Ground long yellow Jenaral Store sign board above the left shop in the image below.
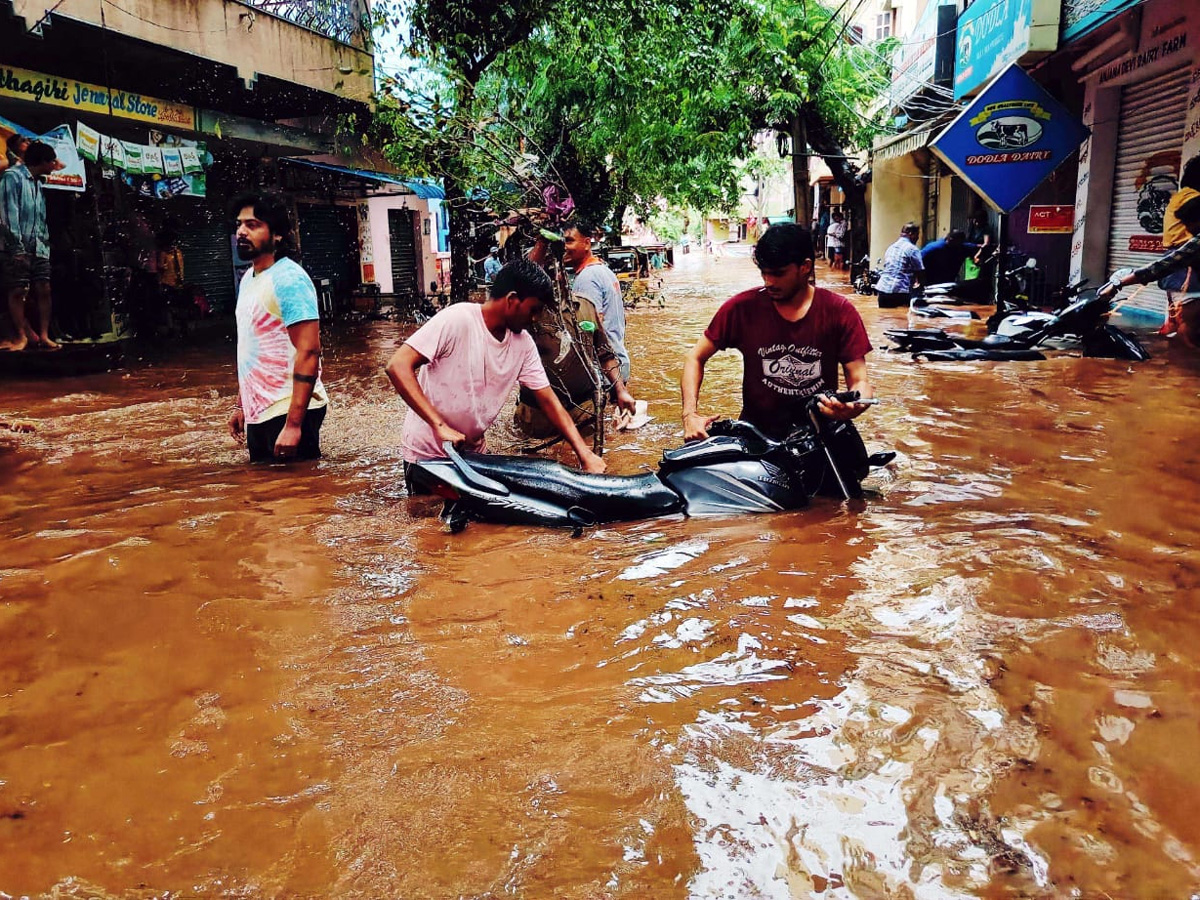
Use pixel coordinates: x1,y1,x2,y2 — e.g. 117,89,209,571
0,66,196,131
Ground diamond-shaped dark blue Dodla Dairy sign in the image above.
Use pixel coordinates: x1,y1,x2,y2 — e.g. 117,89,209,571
930,64,1087,212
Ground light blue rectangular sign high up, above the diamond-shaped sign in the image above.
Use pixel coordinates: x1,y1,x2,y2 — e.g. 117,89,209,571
954,0,1033,100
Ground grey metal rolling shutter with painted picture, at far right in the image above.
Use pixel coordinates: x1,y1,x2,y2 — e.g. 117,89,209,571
1108,68,1189,316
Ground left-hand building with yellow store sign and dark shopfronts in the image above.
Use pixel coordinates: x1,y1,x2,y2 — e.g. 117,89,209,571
0,0,441,337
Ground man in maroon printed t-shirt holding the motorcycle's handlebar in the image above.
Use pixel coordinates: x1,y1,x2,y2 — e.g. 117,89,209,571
680,224,874,440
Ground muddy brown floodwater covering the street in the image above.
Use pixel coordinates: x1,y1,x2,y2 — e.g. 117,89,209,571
0,248,1200,899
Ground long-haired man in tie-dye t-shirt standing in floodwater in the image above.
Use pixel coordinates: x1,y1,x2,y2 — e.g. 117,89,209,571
229,193,329,462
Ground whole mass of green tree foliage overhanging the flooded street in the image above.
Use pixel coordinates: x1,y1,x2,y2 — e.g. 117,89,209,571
377,0,889,260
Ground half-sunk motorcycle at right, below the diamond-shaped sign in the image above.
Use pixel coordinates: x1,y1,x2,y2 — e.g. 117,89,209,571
884,282,1150,361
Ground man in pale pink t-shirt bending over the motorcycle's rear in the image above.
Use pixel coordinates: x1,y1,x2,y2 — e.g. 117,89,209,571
388,259,605,489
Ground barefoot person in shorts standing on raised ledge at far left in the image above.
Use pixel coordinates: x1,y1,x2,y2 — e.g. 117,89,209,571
0,140,59,350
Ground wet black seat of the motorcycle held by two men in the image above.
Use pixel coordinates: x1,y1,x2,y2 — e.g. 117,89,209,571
461,454,683,522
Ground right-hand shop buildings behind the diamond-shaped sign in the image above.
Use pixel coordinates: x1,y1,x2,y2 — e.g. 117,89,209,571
871,0,1200,319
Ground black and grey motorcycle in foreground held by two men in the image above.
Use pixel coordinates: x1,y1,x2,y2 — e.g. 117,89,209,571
409,391,895,535
